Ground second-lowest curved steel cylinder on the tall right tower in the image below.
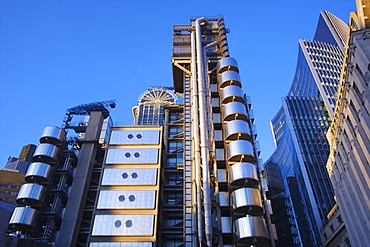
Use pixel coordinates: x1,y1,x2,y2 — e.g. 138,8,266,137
231,188,263,215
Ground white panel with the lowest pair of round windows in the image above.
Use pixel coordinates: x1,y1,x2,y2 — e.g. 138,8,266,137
92,215,154,236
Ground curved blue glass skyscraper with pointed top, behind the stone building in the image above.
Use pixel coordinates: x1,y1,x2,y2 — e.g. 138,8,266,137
265,11,348,246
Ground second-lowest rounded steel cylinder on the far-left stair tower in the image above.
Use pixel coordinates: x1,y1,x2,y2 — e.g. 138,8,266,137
16,184,46,206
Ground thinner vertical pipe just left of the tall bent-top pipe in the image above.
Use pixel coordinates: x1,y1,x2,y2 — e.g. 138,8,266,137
190,31,204,246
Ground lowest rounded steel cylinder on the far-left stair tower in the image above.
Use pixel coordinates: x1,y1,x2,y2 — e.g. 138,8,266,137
9,207,39,232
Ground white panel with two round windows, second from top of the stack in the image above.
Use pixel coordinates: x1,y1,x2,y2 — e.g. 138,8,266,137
105,148,158,164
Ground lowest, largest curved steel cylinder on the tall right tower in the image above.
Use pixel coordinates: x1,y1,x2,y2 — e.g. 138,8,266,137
235,216,269,244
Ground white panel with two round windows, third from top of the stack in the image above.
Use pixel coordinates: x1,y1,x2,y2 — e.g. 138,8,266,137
102,168,157,185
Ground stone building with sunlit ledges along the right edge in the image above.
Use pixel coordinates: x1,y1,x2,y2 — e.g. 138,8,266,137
324,0,370,246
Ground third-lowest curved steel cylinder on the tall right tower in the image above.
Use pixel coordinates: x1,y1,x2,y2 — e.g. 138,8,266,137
229,163,259,188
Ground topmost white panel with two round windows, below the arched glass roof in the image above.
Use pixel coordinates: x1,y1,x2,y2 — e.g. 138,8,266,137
109,130,159,144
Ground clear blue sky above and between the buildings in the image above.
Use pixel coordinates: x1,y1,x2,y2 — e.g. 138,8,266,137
0,0,355,167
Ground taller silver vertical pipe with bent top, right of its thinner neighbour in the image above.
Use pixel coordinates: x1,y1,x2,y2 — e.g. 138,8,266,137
195,17,212,246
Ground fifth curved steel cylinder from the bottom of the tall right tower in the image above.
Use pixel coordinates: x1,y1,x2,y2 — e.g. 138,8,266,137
225,120,252,141
